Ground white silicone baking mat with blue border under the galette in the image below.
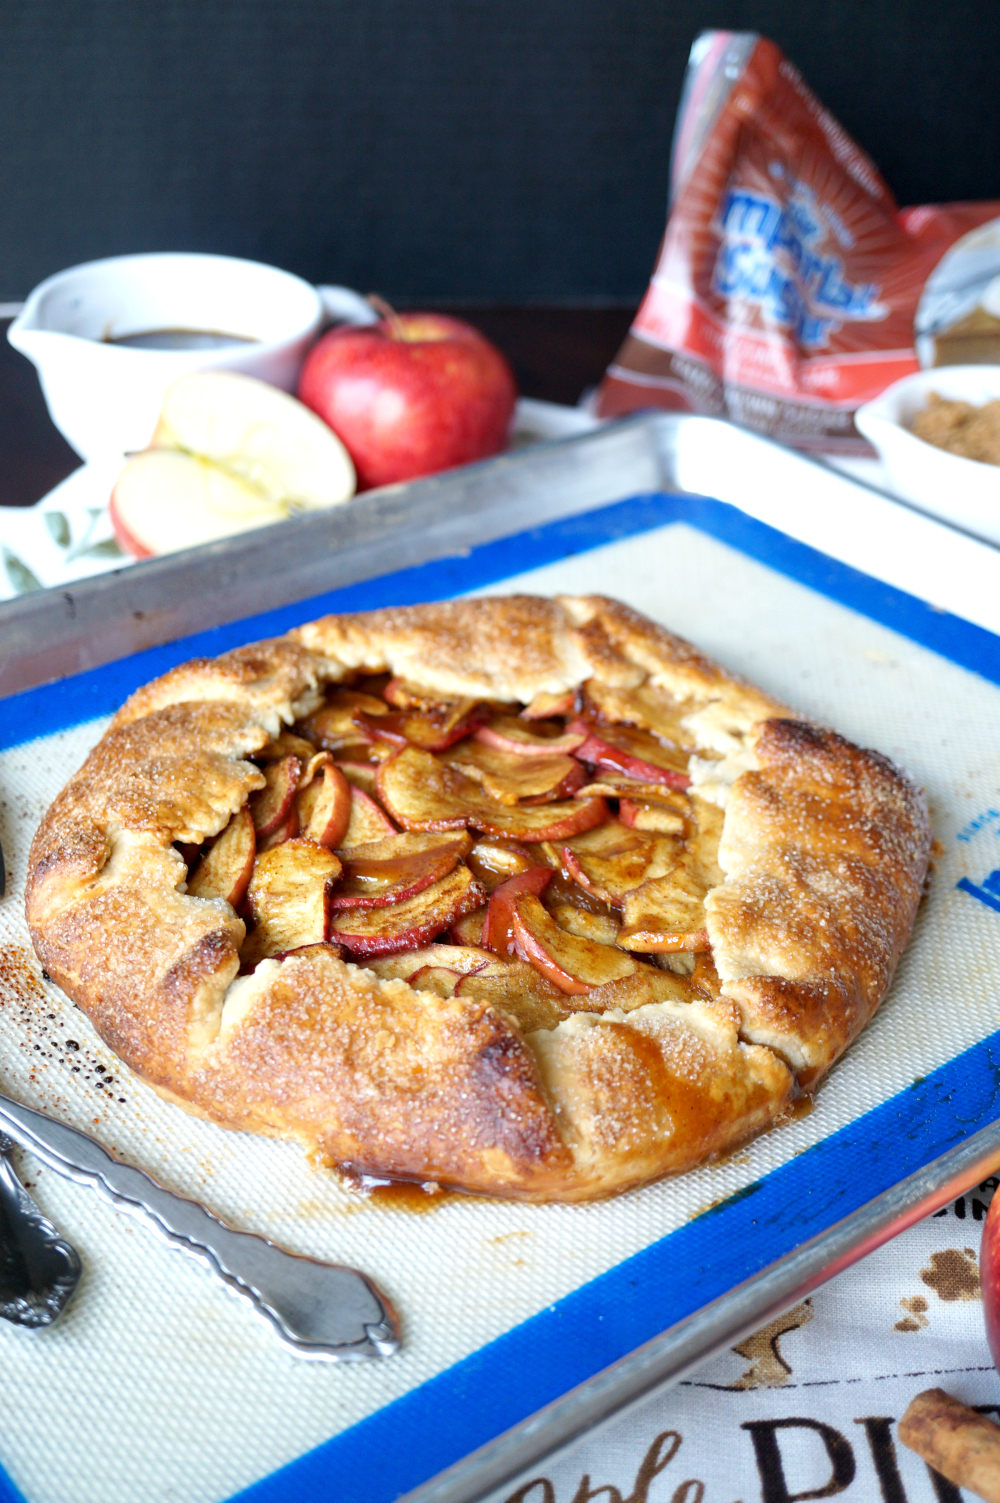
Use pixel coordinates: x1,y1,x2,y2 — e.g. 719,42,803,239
0,496,1000,1503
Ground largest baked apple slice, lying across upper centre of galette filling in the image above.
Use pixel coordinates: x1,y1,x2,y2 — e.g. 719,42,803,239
379,747,608,840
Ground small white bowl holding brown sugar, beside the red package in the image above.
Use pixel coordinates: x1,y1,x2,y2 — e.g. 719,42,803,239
854,365,1000,543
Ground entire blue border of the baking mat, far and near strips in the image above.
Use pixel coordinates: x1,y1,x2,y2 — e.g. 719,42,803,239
0,493,1000,1503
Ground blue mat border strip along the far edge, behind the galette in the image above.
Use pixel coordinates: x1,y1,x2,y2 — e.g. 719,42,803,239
0,491,1000,750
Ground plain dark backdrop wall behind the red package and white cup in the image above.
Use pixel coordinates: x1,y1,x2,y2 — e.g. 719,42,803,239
0,0,1000,307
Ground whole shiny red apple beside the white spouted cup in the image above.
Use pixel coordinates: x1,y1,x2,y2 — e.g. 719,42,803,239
298,313,517,490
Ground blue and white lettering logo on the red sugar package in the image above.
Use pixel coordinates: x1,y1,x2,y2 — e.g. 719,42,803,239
711,177,887,350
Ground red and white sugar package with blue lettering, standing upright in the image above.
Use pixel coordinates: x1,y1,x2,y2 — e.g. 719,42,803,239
597,32,1000,454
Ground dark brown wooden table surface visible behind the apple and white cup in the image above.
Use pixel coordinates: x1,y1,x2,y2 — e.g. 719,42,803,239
0,308,633,507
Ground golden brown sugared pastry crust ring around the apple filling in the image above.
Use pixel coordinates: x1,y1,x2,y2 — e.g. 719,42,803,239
27,597,929,1199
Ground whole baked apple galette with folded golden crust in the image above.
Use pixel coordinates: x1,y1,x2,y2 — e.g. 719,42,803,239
27,597,929,1199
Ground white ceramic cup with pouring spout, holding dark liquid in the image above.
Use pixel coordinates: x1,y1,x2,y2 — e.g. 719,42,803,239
8,253,323,460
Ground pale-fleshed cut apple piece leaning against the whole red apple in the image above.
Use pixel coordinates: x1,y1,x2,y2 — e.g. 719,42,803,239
152,370,356,516
